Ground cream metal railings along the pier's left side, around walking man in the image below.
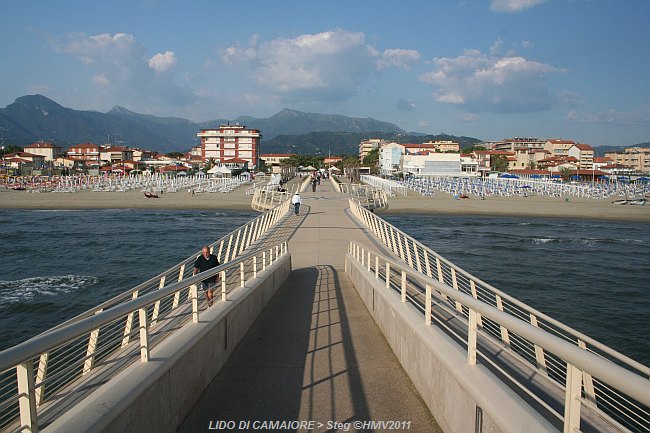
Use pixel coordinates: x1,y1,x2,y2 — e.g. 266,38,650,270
0,201,289,432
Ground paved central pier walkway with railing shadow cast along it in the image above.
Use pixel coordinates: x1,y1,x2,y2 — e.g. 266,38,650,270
178,181,441,433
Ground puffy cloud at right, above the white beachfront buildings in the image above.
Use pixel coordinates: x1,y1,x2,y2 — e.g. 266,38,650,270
420,45,563,113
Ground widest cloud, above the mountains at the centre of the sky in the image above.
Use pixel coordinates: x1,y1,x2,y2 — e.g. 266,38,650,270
221,30,419,101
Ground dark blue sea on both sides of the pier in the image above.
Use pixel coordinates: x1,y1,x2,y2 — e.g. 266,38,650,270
0,209,650,365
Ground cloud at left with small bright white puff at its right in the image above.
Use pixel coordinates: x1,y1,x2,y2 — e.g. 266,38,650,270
52,33,197,108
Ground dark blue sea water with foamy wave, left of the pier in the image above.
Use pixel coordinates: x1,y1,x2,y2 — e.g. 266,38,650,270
0,209,259,350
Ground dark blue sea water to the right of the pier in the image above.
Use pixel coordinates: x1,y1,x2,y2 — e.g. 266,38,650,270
385,215,650,365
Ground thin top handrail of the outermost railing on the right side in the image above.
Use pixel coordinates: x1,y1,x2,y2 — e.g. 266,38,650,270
350,200,650,376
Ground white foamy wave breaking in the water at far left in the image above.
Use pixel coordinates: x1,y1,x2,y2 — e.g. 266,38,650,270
0,275,99,308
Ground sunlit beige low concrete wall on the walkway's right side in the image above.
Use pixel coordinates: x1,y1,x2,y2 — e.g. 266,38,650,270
345,254,558,433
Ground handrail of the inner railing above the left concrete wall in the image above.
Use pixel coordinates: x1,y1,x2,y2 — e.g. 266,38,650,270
0,241,287,372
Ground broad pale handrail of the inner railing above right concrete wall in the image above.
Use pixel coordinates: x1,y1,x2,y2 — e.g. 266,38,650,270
348,241,650,406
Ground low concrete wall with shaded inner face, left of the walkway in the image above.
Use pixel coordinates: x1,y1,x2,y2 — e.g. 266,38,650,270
42,254,291,433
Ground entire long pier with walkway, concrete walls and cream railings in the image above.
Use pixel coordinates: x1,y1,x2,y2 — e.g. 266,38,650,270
0,176,650,433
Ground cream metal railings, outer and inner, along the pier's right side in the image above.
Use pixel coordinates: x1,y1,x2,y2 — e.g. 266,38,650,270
349,200,650,431
